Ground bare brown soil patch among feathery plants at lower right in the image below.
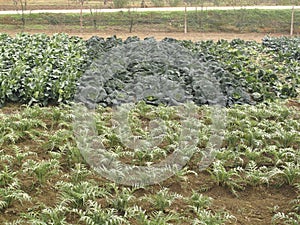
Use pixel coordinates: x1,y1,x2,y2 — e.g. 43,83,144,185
208,187,296,225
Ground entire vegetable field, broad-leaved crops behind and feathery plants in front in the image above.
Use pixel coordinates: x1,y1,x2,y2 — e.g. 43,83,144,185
0,33,300,225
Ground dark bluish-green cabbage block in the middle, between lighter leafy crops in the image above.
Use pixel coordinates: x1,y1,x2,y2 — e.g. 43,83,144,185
75,38,251,106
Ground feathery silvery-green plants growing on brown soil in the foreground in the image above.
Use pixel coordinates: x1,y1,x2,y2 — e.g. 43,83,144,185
0,101,300,225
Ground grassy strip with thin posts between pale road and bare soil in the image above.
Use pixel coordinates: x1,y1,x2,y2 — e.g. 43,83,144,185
0,7,300,34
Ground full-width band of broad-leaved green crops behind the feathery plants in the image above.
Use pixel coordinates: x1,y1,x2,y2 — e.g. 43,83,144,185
0,34,300,106
